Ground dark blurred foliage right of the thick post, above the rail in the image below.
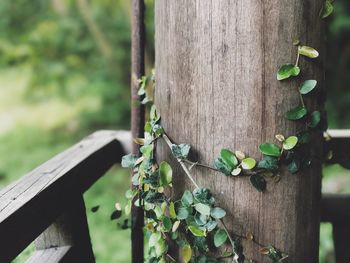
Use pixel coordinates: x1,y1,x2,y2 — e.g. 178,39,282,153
326,0,350,128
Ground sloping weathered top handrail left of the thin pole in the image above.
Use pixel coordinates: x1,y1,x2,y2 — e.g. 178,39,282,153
0,131,124,262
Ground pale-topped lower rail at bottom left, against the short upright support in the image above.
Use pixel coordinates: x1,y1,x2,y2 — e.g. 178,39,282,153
26,246,74,263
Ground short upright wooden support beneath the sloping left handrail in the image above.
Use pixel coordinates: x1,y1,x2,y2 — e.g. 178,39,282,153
34,196,95,263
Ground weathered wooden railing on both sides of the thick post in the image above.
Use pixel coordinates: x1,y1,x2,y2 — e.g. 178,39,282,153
0,131,350,263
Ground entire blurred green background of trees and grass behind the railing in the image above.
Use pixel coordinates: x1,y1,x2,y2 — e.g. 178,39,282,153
0,0,350,263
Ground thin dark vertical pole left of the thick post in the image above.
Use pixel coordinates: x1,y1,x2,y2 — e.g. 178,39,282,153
131,0,145,263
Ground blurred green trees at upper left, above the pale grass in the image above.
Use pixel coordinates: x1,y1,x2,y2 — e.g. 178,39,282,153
0,0,130,128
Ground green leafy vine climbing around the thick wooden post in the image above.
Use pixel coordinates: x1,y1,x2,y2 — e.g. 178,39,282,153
118,4,333,263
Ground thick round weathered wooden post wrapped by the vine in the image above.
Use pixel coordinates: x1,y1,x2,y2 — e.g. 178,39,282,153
155,0,324,262
